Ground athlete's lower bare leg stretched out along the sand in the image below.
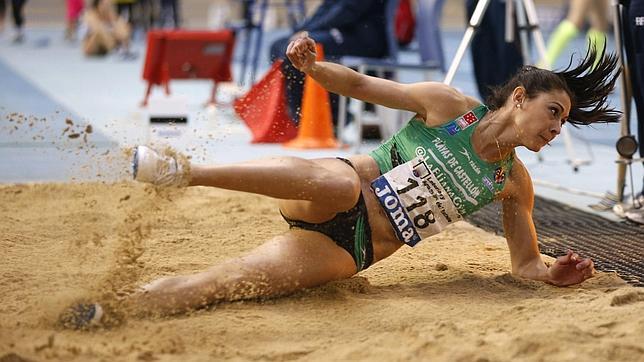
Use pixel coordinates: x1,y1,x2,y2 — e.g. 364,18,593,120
126,230,356,315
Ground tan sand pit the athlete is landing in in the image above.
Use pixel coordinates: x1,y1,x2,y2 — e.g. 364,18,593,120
0,183,644,361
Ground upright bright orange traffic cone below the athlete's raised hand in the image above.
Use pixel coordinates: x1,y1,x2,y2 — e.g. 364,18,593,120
284,44,340,148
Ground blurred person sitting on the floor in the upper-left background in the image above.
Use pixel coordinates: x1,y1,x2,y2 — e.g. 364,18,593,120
83,0,133,58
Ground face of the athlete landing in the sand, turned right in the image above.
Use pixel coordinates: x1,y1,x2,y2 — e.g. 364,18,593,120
512,87,571,152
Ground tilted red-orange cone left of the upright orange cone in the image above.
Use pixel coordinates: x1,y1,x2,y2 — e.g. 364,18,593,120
234,60,297,143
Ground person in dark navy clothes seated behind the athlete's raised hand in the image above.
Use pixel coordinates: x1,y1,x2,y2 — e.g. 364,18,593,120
270,0,388,123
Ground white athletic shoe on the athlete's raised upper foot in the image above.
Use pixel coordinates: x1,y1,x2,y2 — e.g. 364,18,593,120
132,146,184,186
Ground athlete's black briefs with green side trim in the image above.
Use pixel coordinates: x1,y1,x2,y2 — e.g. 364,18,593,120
282,157,373,271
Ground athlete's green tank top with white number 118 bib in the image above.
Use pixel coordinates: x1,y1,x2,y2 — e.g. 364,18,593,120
370,105,514,246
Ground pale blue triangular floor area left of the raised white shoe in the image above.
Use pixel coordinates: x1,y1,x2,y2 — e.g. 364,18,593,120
0,57,126,182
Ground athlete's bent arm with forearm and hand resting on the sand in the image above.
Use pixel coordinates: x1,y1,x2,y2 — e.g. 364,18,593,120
500,159,594,286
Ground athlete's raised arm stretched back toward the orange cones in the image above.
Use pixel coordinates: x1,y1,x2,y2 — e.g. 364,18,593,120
286,34,478,126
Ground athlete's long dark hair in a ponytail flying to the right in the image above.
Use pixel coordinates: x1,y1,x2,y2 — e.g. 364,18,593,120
486,45,622,125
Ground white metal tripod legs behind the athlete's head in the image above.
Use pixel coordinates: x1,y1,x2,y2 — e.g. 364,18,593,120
443,0,591,172
